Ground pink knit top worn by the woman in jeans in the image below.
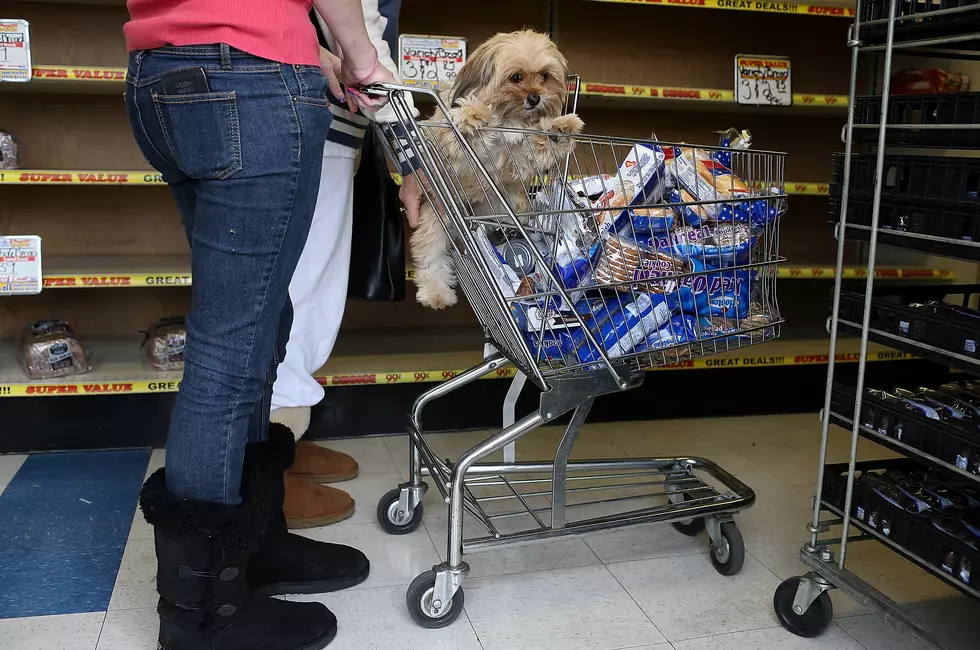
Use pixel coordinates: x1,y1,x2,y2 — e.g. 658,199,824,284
123,0,320,65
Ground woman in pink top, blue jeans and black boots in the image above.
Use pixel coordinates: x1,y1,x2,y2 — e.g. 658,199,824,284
125,0,391,650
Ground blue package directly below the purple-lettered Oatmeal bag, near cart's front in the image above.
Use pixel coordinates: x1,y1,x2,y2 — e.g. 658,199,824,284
664,269,751,320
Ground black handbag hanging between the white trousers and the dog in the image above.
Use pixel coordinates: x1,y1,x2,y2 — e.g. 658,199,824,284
347,128,405,300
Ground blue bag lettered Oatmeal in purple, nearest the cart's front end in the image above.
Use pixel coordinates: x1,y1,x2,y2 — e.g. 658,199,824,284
636,223,756,271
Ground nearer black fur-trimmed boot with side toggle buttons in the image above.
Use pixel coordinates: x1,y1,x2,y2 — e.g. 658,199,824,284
140,467,337,650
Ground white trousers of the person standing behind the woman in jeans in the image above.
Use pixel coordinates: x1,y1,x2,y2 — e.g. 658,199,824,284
272,142,357,410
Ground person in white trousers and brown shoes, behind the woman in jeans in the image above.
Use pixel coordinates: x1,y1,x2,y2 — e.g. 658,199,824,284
272,0,421,528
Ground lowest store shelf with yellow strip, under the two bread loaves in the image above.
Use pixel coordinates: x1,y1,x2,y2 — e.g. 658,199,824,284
0,328,914,397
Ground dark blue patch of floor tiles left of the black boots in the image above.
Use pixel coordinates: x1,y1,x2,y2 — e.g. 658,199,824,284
0,449,150,618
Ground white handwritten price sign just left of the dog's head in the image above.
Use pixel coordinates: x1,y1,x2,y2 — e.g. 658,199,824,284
398,34,466,90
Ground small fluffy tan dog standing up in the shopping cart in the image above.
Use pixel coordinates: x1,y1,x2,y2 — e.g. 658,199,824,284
410,30,583,309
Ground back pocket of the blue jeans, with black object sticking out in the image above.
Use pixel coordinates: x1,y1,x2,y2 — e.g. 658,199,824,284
151,91,242,180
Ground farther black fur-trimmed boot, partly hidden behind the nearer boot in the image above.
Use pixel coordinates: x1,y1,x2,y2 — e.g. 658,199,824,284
245,422,371,596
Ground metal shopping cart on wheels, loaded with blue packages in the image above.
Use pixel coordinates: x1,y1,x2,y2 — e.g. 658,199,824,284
372,78,786,628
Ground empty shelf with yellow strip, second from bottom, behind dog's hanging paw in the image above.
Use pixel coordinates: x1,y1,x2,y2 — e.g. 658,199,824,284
32,256,955,289
